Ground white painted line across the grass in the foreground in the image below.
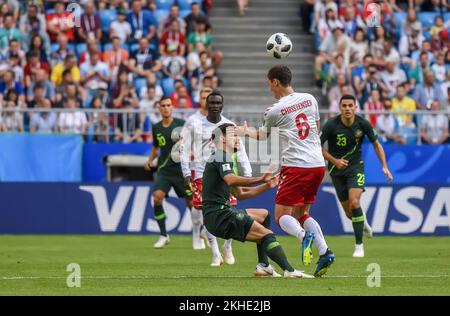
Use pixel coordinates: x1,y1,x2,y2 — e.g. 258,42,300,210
0,275,450,281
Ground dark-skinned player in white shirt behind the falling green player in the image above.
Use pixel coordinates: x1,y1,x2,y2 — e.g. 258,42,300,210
181,92,252,266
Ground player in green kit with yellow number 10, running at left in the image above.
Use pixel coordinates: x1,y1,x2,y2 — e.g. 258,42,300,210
145,97,192,248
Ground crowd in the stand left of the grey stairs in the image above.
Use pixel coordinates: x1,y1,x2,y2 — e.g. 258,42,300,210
0,0,218,142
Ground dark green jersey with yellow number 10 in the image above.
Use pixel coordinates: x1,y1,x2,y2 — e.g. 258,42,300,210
152,118,184,177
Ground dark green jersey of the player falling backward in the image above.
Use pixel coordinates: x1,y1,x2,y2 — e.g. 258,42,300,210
202,150,234,216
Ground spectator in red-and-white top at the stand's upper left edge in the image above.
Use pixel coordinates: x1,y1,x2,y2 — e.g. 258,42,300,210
47,1,75,43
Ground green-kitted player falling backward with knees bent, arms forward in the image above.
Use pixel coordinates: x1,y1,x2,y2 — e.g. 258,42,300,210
202,124,312,278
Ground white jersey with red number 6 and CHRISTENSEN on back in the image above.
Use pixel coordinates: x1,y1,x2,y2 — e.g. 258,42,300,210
263,92,325,168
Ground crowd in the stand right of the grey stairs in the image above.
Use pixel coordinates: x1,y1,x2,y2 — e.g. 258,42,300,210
300,0,450,144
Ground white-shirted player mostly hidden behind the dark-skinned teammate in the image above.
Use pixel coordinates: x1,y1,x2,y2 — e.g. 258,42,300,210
180,87,213,250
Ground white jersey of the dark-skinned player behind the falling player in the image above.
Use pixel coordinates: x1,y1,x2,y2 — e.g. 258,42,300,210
185,115,252,179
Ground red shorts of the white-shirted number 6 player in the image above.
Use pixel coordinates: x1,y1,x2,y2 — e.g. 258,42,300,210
275,167,325,206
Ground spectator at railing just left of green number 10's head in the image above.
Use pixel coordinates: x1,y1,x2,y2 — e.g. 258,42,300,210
114,100,143,143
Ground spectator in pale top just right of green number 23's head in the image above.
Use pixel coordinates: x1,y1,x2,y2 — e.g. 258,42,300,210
376,99,406,144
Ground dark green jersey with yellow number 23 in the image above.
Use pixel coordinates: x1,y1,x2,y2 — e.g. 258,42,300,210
320,115,378,176
